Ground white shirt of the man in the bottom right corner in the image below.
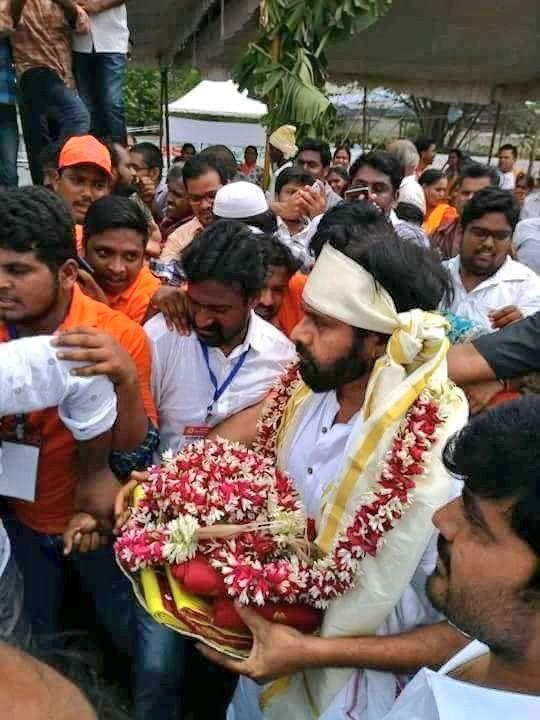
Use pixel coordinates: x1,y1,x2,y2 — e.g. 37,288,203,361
385,640,540,720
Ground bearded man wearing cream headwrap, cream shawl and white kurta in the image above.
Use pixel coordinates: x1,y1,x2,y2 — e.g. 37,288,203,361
202,205,468,720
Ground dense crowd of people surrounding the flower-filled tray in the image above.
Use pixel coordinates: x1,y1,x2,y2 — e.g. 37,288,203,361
0,0,540,720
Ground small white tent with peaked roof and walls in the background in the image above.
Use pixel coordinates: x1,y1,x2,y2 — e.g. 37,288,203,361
169,80,267,155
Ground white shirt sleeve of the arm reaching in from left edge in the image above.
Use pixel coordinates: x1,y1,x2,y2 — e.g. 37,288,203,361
0,335,116,575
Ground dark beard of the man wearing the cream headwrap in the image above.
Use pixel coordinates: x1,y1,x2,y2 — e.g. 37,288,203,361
296,331,375,393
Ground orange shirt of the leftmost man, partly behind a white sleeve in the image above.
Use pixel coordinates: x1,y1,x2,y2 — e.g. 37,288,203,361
0,286,157,535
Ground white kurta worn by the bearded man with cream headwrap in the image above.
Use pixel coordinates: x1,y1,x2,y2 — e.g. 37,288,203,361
227,392,452,720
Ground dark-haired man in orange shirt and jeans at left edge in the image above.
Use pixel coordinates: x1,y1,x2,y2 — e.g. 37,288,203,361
0,187,156,652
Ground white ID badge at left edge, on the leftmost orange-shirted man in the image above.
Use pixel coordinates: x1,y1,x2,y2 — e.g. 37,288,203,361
0,440,39,502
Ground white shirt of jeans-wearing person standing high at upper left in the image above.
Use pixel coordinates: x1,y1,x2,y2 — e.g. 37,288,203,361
73,3,129,55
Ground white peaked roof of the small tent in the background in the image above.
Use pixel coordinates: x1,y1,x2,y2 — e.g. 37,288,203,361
169,80,266,122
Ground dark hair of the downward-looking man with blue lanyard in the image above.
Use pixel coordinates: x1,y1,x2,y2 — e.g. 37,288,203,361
182,220,266,299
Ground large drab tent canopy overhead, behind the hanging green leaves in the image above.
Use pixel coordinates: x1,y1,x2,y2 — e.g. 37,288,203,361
129,0,540,103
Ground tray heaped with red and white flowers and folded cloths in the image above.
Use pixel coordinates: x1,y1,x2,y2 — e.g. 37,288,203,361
115,439,321,656
